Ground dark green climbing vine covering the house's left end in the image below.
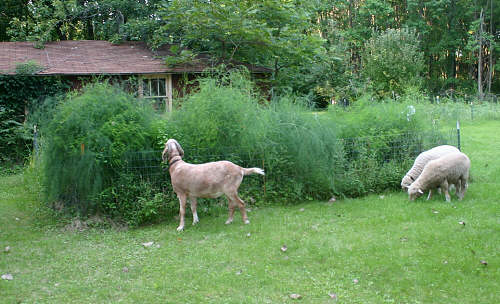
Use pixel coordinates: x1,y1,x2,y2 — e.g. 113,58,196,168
0,62,69,163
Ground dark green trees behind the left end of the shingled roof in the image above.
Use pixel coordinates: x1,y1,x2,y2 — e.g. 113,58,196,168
8,0,159,46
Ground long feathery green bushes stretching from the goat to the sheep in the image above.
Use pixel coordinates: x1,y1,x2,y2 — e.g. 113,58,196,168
163,74,445,201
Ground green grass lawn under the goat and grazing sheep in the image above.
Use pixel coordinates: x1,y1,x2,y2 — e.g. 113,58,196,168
0,121,500,303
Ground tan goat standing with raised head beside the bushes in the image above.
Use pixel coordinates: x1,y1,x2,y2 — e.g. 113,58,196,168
162,139,264,231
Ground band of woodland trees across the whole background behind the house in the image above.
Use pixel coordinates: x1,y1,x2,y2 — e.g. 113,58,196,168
0,0,500,106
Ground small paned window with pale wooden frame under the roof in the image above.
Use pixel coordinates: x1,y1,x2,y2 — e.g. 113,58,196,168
139,75,172,112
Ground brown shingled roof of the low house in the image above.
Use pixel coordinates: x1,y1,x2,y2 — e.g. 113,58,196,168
0,40,269,75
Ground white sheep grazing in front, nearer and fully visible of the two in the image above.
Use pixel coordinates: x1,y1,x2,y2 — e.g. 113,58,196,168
408,152,470,202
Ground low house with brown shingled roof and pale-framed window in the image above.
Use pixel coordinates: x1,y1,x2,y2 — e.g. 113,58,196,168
0,40,270,111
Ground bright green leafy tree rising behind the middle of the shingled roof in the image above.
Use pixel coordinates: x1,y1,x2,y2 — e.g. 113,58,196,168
153,0,324,98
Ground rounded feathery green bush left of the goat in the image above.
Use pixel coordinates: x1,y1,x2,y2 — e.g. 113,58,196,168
41,84,164,215
